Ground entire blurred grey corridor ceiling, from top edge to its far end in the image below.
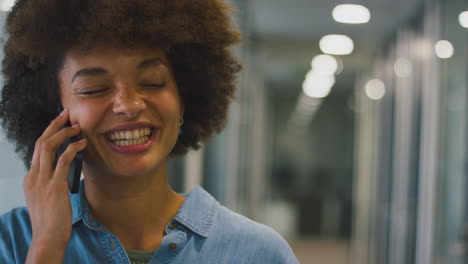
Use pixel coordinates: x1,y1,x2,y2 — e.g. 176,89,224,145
240,0,423,89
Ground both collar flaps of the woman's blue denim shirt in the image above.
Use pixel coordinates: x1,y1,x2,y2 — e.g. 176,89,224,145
70,180,219,237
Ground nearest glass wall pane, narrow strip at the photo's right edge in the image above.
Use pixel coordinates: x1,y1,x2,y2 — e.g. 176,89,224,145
434,1,468,264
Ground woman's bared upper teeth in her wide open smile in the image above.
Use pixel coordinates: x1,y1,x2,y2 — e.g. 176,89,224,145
107,127,153,147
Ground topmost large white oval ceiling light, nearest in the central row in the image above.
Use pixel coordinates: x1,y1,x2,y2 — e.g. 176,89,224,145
332,5,370,24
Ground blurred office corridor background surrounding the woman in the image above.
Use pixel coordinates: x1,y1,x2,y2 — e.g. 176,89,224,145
0,0,468,264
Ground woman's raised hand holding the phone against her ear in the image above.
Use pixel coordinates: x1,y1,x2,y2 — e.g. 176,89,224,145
23,109,86,263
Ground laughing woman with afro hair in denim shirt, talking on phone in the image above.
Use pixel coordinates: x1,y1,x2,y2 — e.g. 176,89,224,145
0,0,297,263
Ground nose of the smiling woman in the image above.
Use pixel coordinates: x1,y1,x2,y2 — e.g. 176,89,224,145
112,85,146,118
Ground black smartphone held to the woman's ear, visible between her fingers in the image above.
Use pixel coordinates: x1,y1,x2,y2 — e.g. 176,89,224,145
54,106,83,193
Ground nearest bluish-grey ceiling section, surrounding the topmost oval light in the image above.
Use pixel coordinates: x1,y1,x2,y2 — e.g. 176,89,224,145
248,0,422,41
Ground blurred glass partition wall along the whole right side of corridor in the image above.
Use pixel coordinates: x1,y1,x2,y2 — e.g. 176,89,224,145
351,0,468,264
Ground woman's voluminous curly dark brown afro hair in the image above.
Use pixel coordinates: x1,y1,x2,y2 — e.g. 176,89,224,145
0,0,241,168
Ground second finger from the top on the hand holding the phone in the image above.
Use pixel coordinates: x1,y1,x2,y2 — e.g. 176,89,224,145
39,124,80,182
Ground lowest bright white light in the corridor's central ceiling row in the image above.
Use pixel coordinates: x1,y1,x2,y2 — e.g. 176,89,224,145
302,71,335,98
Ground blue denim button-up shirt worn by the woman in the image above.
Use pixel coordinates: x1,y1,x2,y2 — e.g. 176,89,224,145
0,182,299,264
